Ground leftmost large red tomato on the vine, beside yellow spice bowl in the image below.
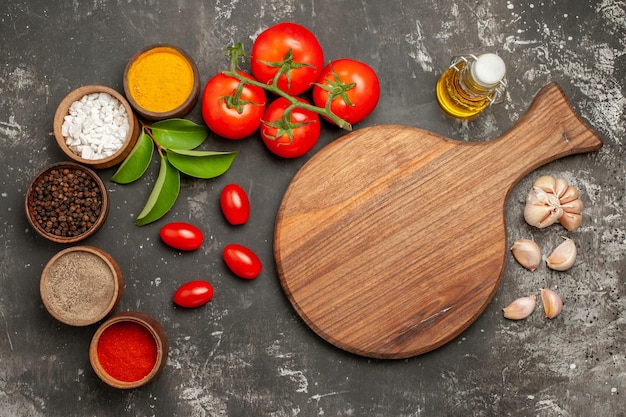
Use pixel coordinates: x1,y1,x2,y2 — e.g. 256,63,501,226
202,72,265,139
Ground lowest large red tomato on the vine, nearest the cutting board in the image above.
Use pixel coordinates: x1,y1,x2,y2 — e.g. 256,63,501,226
261,97,321,158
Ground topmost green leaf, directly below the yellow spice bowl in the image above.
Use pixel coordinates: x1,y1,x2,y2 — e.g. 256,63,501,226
151,119,209,149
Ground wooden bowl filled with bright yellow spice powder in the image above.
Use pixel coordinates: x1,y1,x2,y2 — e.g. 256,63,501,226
124,44,200,121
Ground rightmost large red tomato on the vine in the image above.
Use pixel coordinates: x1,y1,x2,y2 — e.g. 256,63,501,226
313,58,380,124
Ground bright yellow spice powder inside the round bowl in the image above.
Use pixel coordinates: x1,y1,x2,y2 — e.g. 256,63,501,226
127,46,195,113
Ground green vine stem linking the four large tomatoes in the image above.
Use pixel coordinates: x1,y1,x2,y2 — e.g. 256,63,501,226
223,42,352,131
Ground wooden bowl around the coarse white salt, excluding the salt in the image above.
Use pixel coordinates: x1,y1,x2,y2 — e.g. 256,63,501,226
53,84,139,169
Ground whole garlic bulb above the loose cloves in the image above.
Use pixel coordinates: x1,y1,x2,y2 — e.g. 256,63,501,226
524,175,583,231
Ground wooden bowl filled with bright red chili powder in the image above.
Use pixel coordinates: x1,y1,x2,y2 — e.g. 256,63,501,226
89,311,169,389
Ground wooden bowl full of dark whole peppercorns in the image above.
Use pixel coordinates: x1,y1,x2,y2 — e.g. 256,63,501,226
25,162,109,243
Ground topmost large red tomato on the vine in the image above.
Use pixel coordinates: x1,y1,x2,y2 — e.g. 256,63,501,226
250,22,324,96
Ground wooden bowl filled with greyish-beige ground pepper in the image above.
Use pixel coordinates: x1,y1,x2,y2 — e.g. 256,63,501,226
39,246,124,326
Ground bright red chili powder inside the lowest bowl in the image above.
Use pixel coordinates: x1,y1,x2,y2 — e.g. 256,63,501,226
98,321,157,382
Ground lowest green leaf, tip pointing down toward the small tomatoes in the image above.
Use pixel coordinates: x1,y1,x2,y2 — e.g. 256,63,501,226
135,155,180,226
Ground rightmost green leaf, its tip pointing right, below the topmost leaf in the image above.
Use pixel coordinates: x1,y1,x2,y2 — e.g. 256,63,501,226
167,149,237,179
